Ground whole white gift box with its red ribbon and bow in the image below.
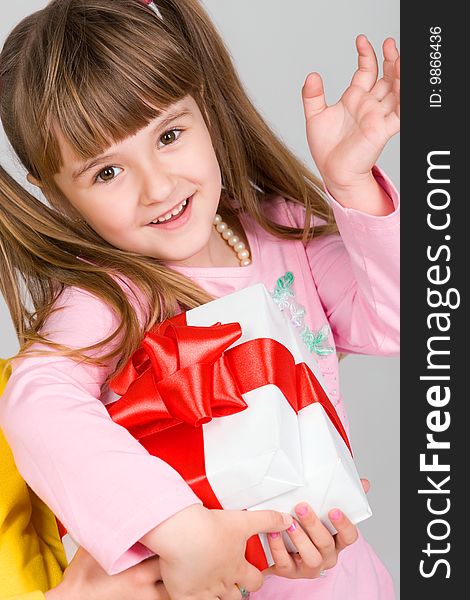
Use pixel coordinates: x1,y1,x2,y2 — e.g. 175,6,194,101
107,284,371,569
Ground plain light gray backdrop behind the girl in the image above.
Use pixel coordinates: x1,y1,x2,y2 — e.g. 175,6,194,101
0,0,399,594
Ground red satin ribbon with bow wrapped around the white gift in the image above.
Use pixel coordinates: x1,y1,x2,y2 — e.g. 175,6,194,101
108,313,351,570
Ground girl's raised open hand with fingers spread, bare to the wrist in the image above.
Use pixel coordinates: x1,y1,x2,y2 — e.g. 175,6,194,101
302,35,400,206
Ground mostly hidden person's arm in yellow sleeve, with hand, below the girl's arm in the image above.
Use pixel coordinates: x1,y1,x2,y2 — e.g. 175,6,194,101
0,368,169,600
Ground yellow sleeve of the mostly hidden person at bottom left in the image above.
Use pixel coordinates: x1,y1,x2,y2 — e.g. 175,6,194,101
0,360,67,600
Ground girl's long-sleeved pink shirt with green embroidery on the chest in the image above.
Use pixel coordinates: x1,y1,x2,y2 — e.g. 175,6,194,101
0,167,399,600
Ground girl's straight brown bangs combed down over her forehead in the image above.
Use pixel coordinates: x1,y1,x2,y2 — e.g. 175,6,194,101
30,0,202,174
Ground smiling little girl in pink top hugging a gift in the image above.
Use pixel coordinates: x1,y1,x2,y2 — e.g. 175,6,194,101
0,0,399,600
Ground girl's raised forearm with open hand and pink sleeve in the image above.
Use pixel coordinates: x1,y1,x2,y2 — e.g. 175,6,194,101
296,35,400,354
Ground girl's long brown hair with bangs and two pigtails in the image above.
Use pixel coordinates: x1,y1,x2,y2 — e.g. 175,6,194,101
0,0,336,382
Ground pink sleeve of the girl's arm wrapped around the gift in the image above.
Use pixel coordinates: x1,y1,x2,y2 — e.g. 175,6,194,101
0,289,200,574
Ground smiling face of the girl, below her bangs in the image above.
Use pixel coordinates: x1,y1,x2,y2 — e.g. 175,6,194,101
54,96,225,266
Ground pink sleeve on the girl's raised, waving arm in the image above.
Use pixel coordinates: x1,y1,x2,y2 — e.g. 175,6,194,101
288,167,400,355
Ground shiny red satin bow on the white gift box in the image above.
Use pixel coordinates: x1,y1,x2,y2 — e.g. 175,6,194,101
109,315,247,439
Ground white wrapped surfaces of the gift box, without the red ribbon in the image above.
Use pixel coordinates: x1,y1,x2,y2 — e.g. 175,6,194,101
103,284,372,564
